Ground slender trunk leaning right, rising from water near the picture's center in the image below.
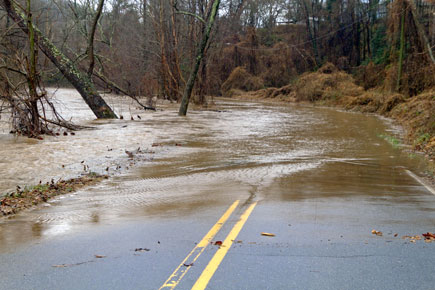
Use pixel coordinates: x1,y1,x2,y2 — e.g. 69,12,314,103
178,0,220,116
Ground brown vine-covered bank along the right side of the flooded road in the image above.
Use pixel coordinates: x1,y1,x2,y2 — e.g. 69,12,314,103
224,63,435,178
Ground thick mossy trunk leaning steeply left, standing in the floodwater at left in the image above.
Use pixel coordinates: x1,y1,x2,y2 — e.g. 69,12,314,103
0,0,117,118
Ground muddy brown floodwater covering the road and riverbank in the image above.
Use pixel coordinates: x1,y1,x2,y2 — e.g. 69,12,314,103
0,89,433,251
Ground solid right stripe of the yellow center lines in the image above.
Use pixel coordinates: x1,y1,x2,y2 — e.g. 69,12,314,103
191,202,257,290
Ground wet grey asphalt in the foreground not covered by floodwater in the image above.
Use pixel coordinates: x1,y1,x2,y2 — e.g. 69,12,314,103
0,190,435,289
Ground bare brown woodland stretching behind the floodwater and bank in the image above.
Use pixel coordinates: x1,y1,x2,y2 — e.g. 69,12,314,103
0,0,435,139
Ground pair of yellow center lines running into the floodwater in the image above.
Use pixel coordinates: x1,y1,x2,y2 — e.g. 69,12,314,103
159,200,257,290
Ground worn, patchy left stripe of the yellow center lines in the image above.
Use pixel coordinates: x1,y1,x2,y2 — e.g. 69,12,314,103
159,200,240,290
